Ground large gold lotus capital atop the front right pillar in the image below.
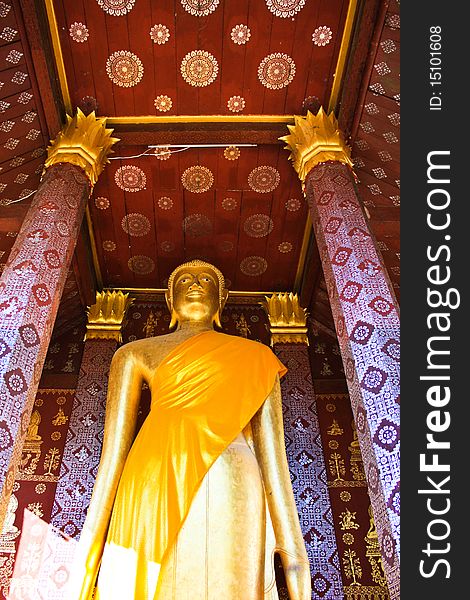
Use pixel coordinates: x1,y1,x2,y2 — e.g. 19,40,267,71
279,107,353,183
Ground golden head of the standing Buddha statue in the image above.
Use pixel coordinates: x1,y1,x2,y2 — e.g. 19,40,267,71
165,260,228,329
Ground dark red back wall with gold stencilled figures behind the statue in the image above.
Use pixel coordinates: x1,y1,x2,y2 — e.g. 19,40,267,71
0,301,388,600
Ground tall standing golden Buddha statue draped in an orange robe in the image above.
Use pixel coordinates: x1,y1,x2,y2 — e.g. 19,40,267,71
67,261,311,600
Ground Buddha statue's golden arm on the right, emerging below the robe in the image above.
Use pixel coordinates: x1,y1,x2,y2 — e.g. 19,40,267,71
252,378,311,600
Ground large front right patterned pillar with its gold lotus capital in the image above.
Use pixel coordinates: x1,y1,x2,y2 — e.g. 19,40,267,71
282,109,400,599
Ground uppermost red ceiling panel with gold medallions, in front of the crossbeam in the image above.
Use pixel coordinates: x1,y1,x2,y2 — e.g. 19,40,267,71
54,0,348,116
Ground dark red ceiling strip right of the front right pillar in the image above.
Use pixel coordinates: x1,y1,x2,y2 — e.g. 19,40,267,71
353,0,400,295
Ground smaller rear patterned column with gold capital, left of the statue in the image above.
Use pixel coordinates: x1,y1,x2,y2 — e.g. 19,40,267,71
51,292,131,537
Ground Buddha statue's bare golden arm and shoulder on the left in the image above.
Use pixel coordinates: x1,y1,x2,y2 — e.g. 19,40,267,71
68,347,142,600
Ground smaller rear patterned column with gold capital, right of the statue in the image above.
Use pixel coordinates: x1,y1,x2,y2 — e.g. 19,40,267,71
264,294,344,598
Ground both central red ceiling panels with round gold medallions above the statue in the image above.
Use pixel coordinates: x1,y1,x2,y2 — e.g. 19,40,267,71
47,0,348,291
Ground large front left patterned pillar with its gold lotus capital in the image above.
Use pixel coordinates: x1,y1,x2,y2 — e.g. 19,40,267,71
0,111,117,523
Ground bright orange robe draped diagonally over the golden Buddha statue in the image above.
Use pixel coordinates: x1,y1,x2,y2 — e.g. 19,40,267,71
98,331,287,600
